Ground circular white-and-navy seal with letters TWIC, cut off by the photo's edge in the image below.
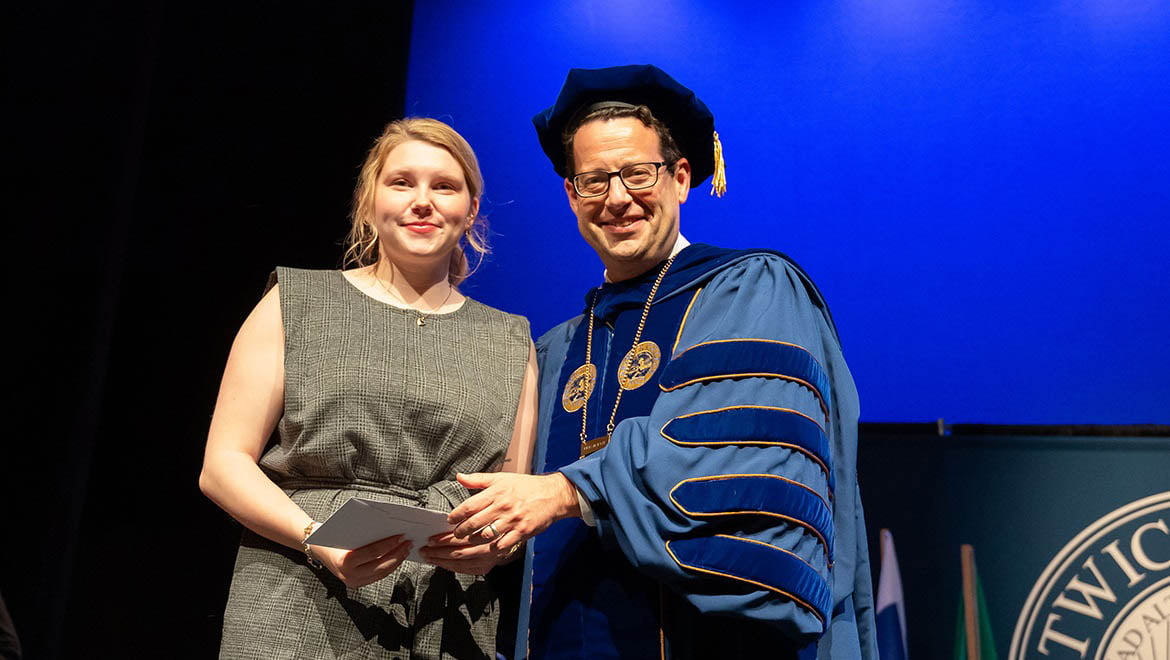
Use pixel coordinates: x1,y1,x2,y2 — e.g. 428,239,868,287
1009,491,1170,660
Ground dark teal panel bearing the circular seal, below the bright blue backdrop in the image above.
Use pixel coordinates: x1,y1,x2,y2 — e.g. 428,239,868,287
858,425,1170,660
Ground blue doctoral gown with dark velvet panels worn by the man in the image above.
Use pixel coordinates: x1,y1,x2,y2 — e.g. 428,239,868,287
517,245,876,660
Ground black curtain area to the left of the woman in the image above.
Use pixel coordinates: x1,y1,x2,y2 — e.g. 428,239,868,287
0,1,412,658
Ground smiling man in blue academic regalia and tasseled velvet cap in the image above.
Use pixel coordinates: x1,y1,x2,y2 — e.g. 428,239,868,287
450,66,876,659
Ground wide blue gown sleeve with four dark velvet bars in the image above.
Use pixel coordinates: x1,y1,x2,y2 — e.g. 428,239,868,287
562,254,863,639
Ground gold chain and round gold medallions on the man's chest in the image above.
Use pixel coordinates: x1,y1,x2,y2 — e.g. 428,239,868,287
560,256,674,459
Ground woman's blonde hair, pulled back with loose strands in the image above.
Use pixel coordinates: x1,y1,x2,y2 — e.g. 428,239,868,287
343,117,488,284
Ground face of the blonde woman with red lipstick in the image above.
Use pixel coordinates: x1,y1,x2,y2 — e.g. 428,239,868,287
373,140,480,270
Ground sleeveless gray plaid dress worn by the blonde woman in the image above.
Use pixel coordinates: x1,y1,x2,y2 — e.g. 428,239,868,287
220,268,530,660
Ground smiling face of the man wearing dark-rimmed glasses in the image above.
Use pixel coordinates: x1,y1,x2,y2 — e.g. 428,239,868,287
565,117,690,282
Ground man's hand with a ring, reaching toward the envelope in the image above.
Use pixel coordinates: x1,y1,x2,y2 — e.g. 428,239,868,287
447,472,580,552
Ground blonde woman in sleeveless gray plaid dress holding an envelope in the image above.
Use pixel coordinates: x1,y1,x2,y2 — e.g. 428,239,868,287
199,118,536,659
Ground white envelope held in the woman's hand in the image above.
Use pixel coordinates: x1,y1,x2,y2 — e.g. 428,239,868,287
305,497,454,562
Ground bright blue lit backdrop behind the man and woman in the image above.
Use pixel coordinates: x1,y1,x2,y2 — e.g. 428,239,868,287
406,0,1170,424
